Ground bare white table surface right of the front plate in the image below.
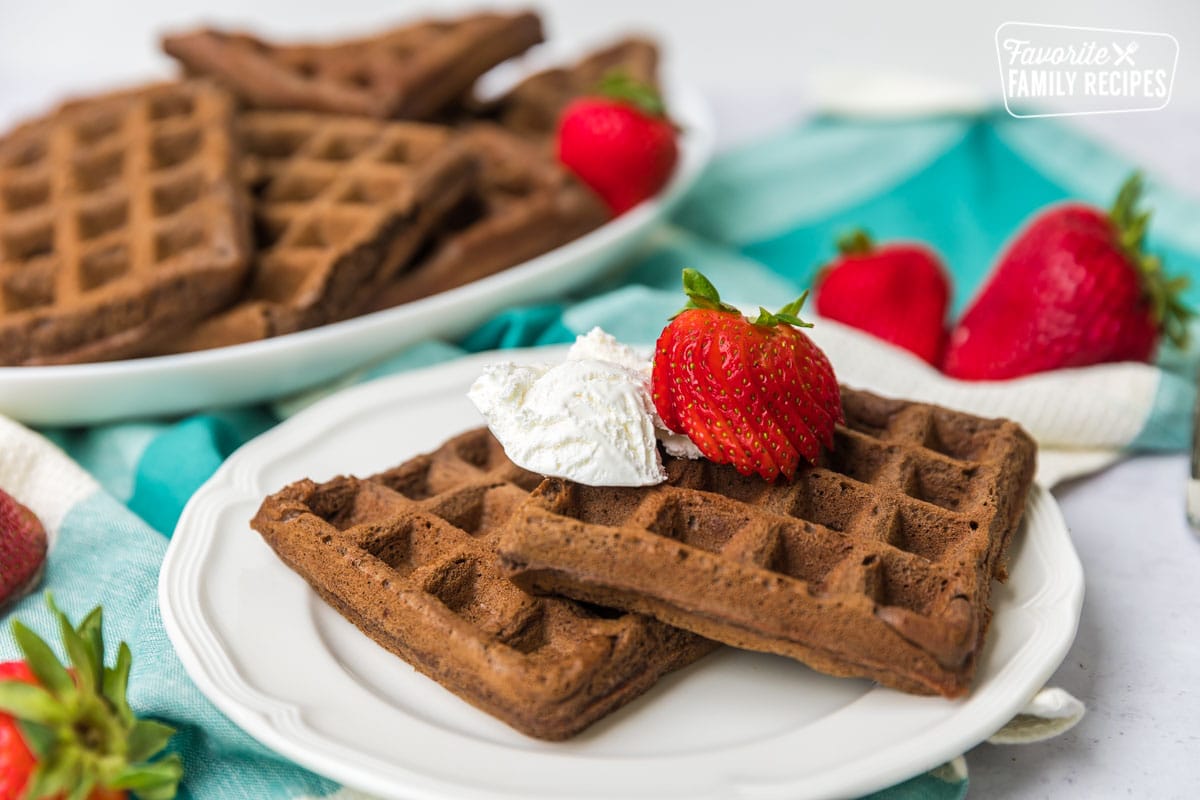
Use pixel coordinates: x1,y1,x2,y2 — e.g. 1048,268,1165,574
967,456,1200,799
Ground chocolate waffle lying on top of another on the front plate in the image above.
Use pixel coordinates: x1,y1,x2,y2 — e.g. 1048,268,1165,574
498,389,1034,697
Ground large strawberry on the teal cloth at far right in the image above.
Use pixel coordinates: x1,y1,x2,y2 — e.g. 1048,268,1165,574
942,174,1193,380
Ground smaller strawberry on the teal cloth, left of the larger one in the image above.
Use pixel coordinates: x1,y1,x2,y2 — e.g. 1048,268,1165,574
817,230,950,363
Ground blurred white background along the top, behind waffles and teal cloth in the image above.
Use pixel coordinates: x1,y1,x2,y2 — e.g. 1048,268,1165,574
0,0,1200,189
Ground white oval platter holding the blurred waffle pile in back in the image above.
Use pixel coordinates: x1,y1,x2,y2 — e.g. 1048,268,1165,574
0,85,714,425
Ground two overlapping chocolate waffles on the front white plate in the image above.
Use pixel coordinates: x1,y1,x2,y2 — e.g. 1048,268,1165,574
252,389,1034,739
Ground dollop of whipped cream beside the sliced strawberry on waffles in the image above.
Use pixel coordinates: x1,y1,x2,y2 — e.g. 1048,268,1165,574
467,327,701,486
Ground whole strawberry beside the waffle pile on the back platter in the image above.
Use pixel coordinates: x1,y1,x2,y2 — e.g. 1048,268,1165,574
558,73,679,213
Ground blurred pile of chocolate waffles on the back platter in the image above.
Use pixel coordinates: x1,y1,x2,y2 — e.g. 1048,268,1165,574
0,12,656,366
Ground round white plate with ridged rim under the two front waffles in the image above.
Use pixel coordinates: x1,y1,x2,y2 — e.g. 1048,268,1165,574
158,349,1084,800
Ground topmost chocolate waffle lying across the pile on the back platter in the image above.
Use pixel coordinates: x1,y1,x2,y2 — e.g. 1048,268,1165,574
163,12,542,120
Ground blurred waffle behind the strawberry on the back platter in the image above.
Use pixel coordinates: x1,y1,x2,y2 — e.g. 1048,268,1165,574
484,36,659,137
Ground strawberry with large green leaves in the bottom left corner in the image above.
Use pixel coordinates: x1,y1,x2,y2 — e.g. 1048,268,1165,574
0,595,182,800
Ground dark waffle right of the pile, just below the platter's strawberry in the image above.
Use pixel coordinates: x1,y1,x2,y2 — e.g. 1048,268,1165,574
357,124,608,311
